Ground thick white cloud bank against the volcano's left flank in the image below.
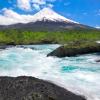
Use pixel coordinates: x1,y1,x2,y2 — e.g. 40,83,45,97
0,8,33,25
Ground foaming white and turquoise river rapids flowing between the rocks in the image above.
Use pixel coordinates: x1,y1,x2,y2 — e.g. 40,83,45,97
0,45,100,100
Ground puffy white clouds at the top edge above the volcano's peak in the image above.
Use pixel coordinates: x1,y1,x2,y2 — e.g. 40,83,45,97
17,0,56,11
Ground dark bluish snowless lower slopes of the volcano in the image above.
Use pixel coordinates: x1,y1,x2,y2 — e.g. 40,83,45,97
0,20,94,31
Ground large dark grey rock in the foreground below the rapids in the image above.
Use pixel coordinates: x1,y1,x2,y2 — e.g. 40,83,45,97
0,76,86,100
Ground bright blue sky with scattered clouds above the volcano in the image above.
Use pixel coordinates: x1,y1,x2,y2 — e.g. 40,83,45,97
0,0,100,27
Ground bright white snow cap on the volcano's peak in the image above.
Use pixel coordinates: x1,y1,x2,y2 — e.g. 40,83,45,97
33,8,77,23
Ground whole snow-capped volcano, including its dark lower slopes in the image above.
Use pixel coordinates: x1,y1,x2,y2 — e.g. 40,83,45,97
0,8,91,31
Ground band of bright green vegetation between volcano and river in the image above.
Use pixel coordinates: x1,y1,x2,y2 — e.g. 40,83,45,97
0,29,100,44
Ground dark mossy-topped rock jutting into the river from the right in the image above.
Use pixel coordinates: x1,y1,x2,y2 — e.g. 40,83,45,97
47,42,100,57
